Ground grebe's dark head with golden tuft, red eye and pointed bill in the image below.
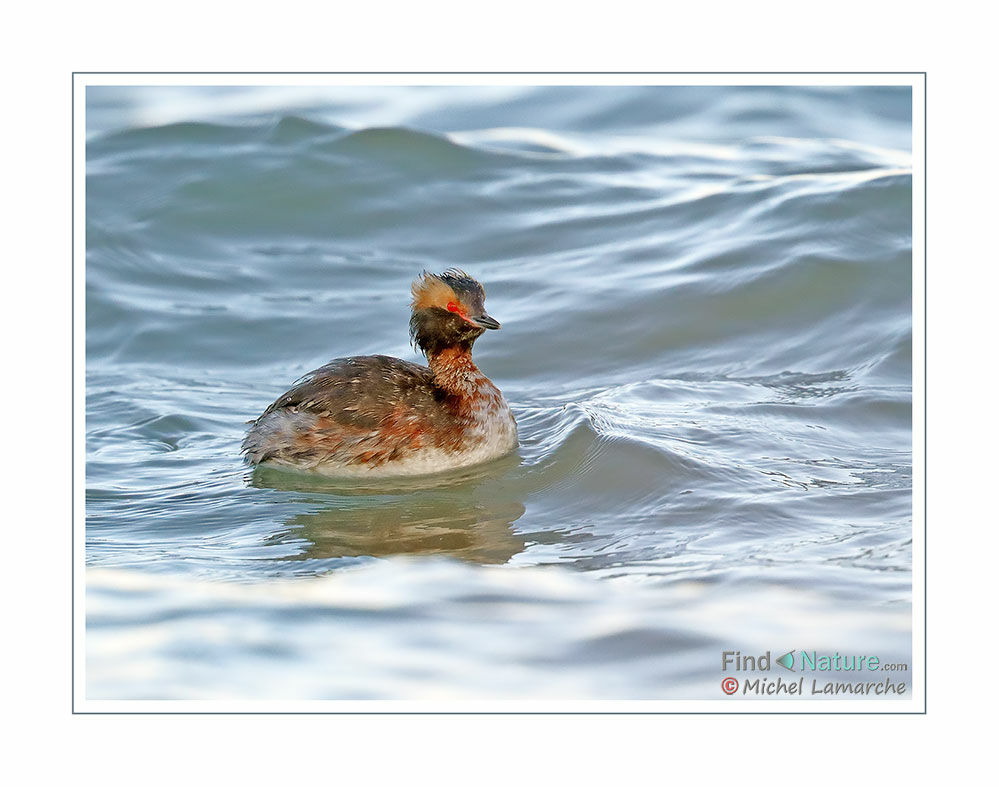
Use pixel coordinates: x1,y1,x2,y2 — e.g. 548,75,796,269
409,268,500,357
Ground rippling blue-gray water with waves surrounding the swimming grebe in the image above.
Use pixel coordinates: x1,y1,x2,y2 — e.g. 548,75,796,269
86,87,912,699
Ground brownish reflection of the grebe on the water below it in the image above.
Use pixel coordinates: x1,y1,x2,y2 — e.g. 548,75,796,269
250,456,526,563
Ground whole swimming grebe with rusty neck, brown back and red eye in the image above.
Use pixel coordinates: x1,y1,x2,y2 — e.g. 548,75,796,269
242,268,517,477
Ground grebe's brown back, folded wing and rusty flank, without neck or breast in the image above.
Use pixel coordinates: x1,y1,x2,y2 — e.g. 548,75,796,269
243,355,447,465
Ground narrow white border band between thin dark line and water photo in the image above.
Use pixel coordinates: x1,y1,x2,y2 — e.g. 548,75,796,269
73,72,926,714
